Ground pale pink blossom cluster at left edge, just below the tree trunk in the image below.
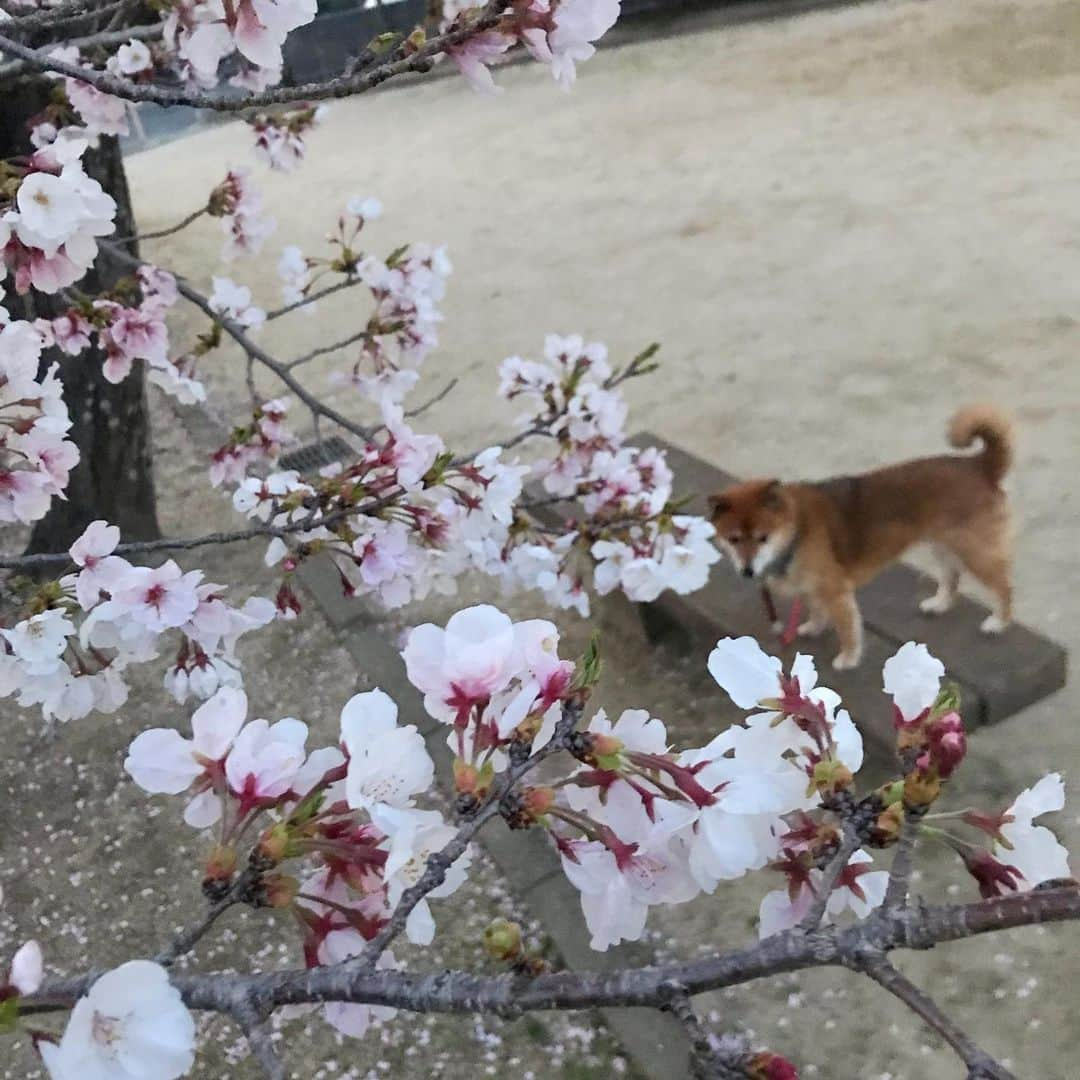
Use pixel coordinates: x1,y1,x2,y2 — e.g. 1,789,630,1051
0,522,275,721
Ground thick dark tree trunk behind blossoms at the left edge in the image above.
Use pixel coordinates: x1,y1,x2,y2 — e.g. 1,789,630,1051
0,82,161,552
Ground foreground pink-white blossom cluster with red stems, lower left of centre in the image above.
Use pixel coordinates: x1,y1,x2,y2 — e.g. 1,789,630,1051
124,687,470,1036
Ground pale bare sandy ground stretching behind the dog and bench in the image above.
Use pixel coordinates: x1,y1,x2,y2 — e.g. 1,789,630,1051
130,0,1080,630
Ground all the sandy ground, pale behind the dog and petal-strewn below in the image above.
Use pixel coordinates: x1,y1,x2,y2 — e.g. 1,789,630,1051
6,0,1080,1080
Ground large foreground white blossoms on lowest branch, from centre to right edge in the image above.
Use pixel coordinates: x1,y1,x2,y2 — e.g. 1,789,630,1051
403,606,1068,949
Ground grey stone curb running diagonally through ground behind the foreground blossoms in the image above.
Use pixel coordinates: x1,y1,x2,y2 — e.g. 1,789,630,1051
297,559,691,1080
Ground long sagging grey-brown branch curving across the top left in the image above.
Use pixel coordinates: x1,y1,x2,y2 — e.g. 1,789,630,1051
0,0,505,112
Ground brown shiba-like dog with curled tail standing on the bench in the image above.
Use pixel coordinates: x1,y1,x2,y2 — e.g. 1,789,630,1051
710,405,1013,669
